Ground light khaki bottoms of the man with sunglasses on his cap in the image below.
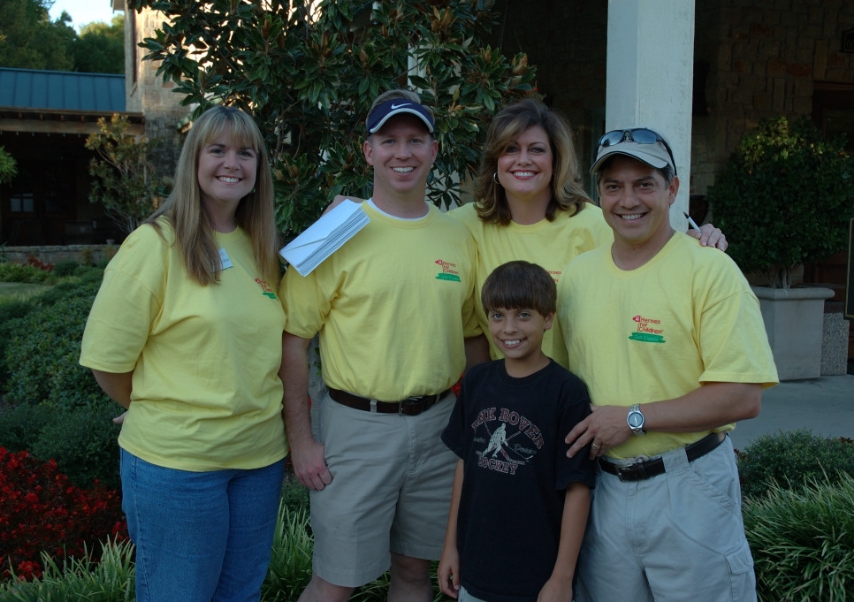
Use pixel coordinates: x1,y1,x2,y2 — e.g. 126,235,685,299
575,437,756,602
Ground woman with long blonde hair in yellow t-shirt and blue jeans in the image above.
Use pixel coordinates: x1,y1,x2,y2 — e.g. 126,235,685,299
80,106,287,602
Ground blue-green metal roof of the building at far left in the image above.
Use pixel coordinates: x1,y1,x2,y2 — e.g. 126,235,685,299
0,67,125,113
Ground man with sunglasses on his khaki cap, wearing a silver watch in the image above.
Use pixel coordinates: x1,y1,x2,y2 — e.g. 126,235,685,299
558,128,777,602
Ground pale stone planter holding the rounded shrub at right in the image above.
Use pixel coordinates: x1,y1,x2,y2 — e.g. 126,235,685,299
751,286,833,380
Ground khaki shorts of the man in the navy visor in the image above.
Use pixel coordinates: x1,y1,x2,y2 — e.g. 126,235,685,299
311,386,457,587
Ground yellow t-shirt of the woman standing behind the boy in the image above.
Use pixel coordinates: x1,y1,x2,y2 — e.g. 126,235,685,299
449,203,614,368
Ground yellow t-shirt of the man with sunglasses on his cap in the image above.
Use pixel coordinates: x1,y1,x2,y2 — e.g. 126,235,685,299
558,232,778,459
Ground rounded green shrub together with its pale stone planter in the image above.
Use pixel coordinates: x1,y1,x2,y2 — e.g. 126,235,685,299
707,117,854,380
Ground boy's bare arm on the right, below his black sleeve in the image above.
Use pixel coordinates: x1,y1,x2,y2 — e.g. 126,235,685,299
537,482,590,602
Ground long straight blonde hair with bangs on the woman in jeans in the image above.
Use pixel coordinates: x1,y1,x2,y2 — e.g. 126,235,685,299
145,106,279,286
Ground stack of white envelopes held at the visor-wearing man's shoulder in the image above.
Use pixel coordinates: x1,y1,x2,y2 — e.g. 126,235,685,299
279,199,371,276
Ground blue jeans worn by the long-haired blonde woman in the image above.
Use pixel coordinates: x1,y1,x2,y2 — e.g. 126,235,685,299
121,450,285,602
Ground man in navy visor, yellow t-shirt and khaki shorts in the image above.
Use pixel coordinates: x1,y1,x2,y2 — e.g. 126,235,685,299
280,90,480,602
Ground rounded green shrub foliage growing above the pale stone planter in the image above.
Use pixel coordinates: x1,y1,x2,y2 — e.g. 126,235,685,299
707,117,854,288
